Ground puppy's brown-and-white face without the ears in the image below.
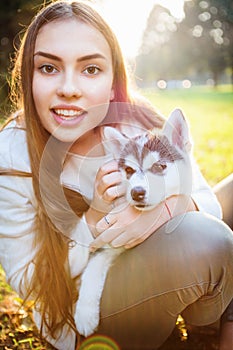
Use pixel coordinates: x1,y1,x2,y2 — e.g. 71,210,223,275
119,135,189,210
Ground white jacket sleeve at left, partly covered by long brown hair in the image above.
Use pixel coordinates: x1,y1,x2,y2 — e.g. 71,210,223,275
0,172,93,296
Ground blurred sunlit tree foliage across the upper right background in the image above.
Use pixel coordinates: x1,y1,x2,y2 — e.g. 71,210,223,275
136,0,233,85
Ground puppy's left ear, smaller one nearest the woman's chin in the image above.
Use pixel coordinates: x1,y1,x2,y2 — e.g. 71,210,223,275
104,126,129,158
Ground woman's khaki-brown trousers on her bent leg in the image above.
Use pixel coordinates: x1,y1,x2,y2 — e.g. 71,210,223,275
95,212,233,350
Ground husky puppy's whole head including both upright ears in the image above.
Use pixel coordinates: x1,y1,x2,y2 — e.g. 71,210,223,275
105,110,192,210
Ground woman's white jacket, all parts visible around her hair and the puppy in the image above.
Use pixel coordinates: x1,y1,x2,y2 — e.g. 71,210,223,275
0,124,221,350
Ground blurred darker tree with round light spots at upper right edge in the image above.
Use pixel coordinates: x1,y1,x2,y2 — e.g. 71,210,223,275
178,0,232,84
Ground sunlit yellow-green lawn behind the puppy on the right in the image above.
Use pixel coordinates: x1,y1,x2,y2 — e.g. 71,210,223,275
142,86,233,185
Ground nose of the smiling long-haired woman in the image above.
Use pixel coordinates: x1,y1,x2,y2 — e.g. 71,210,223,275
57,71,82,98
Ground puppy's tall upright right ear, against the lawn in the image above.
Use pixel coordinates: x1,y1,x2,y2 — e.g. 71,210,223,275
162,109,191,152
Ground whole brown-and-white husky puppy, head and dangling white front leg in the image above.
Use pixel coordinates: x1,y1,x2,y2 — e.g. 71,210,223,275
75,109,192,336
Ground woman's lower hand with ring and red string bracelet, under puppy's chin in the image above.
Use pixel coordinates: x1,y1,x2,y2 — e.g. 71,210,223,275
90,195,197,252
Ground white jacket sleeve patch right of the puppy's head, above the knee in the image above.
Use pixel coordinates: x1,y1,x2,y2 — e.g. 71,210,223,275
192,160,222,219
